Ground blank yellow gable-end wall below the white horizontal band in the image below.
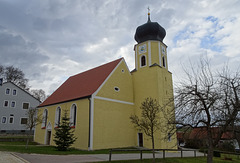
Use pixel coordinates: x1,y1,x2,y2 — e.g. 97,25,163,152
93,99,137,150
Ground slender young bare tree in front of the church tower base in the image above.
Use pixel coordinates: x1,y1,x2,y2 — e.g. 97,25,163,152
130,97,160,162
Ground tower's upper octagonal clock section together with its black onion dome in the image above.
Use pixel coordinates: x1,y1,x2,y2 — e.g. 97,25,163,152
135,13,168,70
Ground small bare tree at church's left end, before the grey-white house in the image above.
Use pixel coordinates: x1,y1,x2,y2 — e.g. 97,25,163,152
25,108,41,148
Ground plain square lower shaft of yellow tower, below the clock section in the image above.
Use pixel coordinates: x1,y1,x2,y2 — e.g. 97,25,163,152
133,66,177,149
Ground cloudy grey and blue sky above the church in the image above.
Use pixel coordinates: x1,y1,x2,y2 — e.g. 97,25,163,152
0,0,240,94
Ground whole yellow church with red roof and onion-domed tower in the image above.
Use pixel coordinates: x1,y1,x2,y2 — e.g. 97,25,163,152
34,13,177,150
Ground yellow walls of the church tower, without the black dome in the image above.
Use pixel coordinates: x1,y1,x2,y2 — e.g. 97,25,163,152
132,41,177,148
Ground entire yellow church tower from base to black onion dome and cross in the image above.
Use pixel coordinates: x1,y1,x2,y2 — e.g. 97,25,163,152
132,13,176,148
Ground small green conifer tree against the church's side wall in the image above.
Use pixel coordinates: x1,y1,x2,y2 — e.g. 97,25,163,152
53,111,77,151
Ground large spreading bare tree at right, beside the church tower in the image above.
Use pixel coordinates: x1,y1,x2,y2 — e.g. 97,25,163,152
170,59,240,163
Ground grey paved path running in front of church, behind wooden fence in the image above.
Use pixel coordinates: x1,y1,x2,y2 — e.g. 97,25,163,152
0,151,203,163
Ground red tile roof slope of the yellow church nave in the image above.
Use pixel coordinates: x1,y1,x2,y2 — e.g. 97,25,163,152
39,58,123,107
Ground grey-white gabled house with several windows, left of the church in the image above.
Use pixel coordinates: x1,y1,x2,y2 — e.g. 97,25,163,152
0,82,40,134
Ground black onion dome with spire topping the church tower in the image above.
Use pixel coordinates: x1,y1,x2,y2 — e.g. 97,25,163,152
134,15,166,43
